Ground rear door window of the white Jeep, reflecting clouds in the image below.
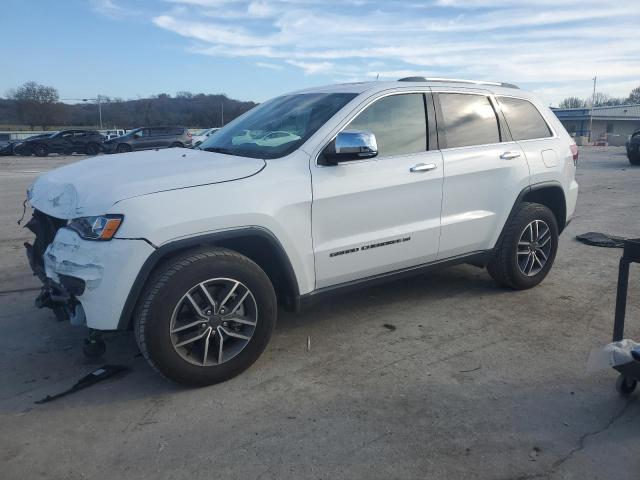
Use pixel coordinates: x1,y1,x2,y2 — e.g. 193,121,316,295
438,93,500,148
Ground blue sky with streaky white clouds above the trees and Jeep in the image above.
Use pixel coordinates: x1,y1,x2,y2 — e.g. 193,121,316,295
0,0,640,105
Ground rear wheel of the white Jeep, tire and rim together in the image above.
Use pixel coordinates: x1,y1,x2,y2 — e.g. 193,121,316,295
487,202,558,290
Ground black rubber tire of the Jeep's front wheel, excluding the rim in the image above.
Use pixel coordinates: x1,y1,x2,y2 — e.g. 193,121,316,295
134,248,277,386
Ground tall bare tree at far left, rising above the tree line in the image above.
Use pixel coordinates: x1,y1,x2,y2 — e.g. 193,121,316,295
7,82,62,130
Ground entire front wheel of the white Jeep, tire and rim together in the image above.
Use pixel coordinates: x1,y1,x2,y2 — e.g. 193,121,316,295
134,249,277,386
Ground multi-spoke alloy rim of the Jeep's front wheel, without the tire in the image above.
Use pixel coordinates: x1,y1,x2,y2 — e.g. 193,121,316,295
169,278,258,367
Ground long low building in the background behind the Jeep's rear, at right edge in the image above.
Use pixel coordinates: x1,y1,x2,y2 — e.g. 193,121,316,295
552,105,640,146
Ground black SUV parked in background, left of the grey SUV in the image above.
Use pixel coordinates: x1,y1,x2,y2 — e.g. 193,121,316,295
20,130,102,157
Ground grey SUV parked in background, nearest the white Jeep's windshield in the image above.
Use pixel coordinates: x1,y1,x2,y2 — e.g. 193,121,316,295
102,127,192,153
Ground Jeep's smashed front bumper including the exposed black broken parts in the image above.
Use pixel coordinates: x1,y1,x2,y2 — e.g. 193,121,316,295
25,211,154,330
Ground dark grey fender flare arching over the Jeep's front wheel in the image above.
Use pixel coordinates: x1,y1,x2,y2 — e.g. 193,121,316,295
117,226,300,330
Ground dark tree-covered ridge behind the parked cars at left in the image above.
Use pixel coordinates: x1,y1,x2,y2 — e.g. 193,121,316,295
0,82,257,130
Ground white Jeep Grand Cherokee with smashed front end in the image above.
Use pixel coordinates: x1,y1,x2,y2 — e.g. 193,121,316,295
27,77,578,385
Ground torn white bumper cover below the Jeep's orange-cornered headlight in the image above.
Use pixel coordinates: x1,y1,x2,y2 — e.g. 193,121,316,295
39,228,154,330
